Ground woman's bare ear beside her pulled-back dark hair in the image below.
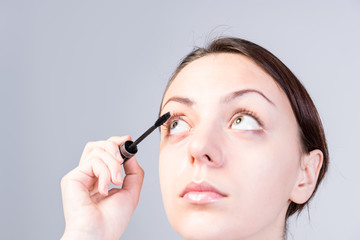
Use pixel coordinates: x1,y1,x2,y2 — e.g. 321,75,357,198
290,149,323,204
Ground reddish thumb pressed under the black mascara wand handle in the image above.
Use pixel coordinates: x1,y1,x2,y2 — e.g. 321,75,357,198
122,157,144,206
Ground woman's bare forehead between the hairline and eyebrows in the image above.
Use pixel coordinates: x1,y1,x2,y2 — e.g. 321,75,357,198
163,53,287,108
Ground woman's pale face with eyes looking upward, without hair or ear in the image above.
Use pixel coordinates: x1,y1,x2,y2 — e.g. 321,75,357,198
159,53,302,239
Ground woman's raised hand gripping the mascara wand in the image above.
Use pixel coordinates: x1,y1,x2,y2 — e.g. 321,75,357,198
61,137,144,240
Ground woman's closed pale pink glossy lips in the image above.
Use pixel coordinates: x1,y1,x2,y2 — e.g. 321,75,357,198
180,181,227,205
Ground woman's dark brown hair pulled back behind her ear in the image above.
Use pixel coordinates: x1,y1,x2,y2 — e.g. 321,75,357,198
164,38,329,219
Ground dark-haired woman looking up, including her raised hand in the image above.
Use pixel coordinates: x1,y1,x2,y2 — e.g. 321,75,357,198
62,38,328,239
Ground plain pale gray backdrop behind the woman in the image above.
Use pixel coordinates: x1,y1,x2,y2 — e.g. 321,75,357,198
0,0,360,239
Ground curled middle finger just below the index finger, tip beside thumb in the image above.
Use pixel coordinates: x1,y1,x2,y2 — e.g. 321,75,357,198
85,148,123,185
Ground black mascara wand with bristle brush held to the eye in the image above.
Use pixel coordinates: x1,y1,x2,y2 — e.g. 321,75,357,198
119,112,170,163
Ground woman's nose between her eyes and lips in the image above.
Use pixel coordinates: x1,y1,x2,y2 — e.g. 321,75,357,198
188,124,224,168
